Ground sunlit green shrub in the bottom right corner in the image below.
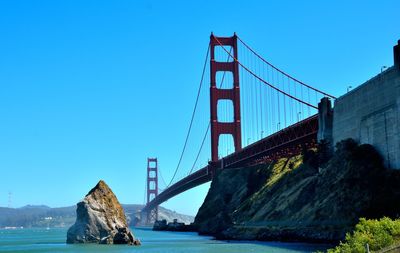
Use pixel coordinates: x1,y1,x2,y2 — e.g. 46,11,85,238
328,217,400,253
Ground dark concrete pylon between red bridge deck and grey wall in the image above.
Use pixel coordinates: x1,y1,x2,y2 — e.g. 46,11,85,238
317,97,333,148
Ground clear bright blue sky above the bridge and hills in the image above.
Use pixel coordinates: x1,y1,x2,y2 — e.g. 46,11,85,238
0,0,400,214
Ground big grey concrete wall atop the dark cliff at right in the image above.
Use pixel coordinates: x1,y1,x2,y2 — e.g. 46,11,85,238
332,66,400,169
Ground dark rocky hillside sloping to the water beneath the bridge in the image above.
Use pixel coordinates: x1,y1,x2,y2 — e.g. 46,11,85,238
195,140,400,242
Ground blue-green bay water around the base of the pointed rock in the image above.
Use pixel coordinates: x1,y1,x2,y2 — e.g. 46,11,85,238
0,228,326,253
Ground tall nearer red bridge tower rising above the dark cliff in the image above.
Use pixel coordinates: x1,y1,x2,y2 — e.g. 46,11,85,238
210,33,242,162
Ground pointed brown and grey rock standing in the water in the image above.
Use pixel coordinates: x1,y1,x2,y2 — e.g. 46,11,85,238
67,180,140,245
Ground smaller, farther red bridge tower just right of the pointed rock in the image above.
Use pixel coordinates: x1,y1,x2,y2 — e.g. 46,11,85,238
146,158,158,224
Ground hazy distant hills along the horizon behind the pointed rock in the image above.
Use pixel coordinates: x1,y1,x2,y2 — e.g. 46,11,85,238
0,204,194,228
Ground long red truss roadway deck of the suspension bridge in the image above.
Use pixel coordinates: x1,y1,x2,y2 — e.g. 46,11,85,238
142,114,318,212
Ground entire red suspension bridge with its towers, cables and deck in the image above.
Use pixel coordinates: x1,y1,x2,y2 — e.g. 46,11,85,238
142,34,335,221
